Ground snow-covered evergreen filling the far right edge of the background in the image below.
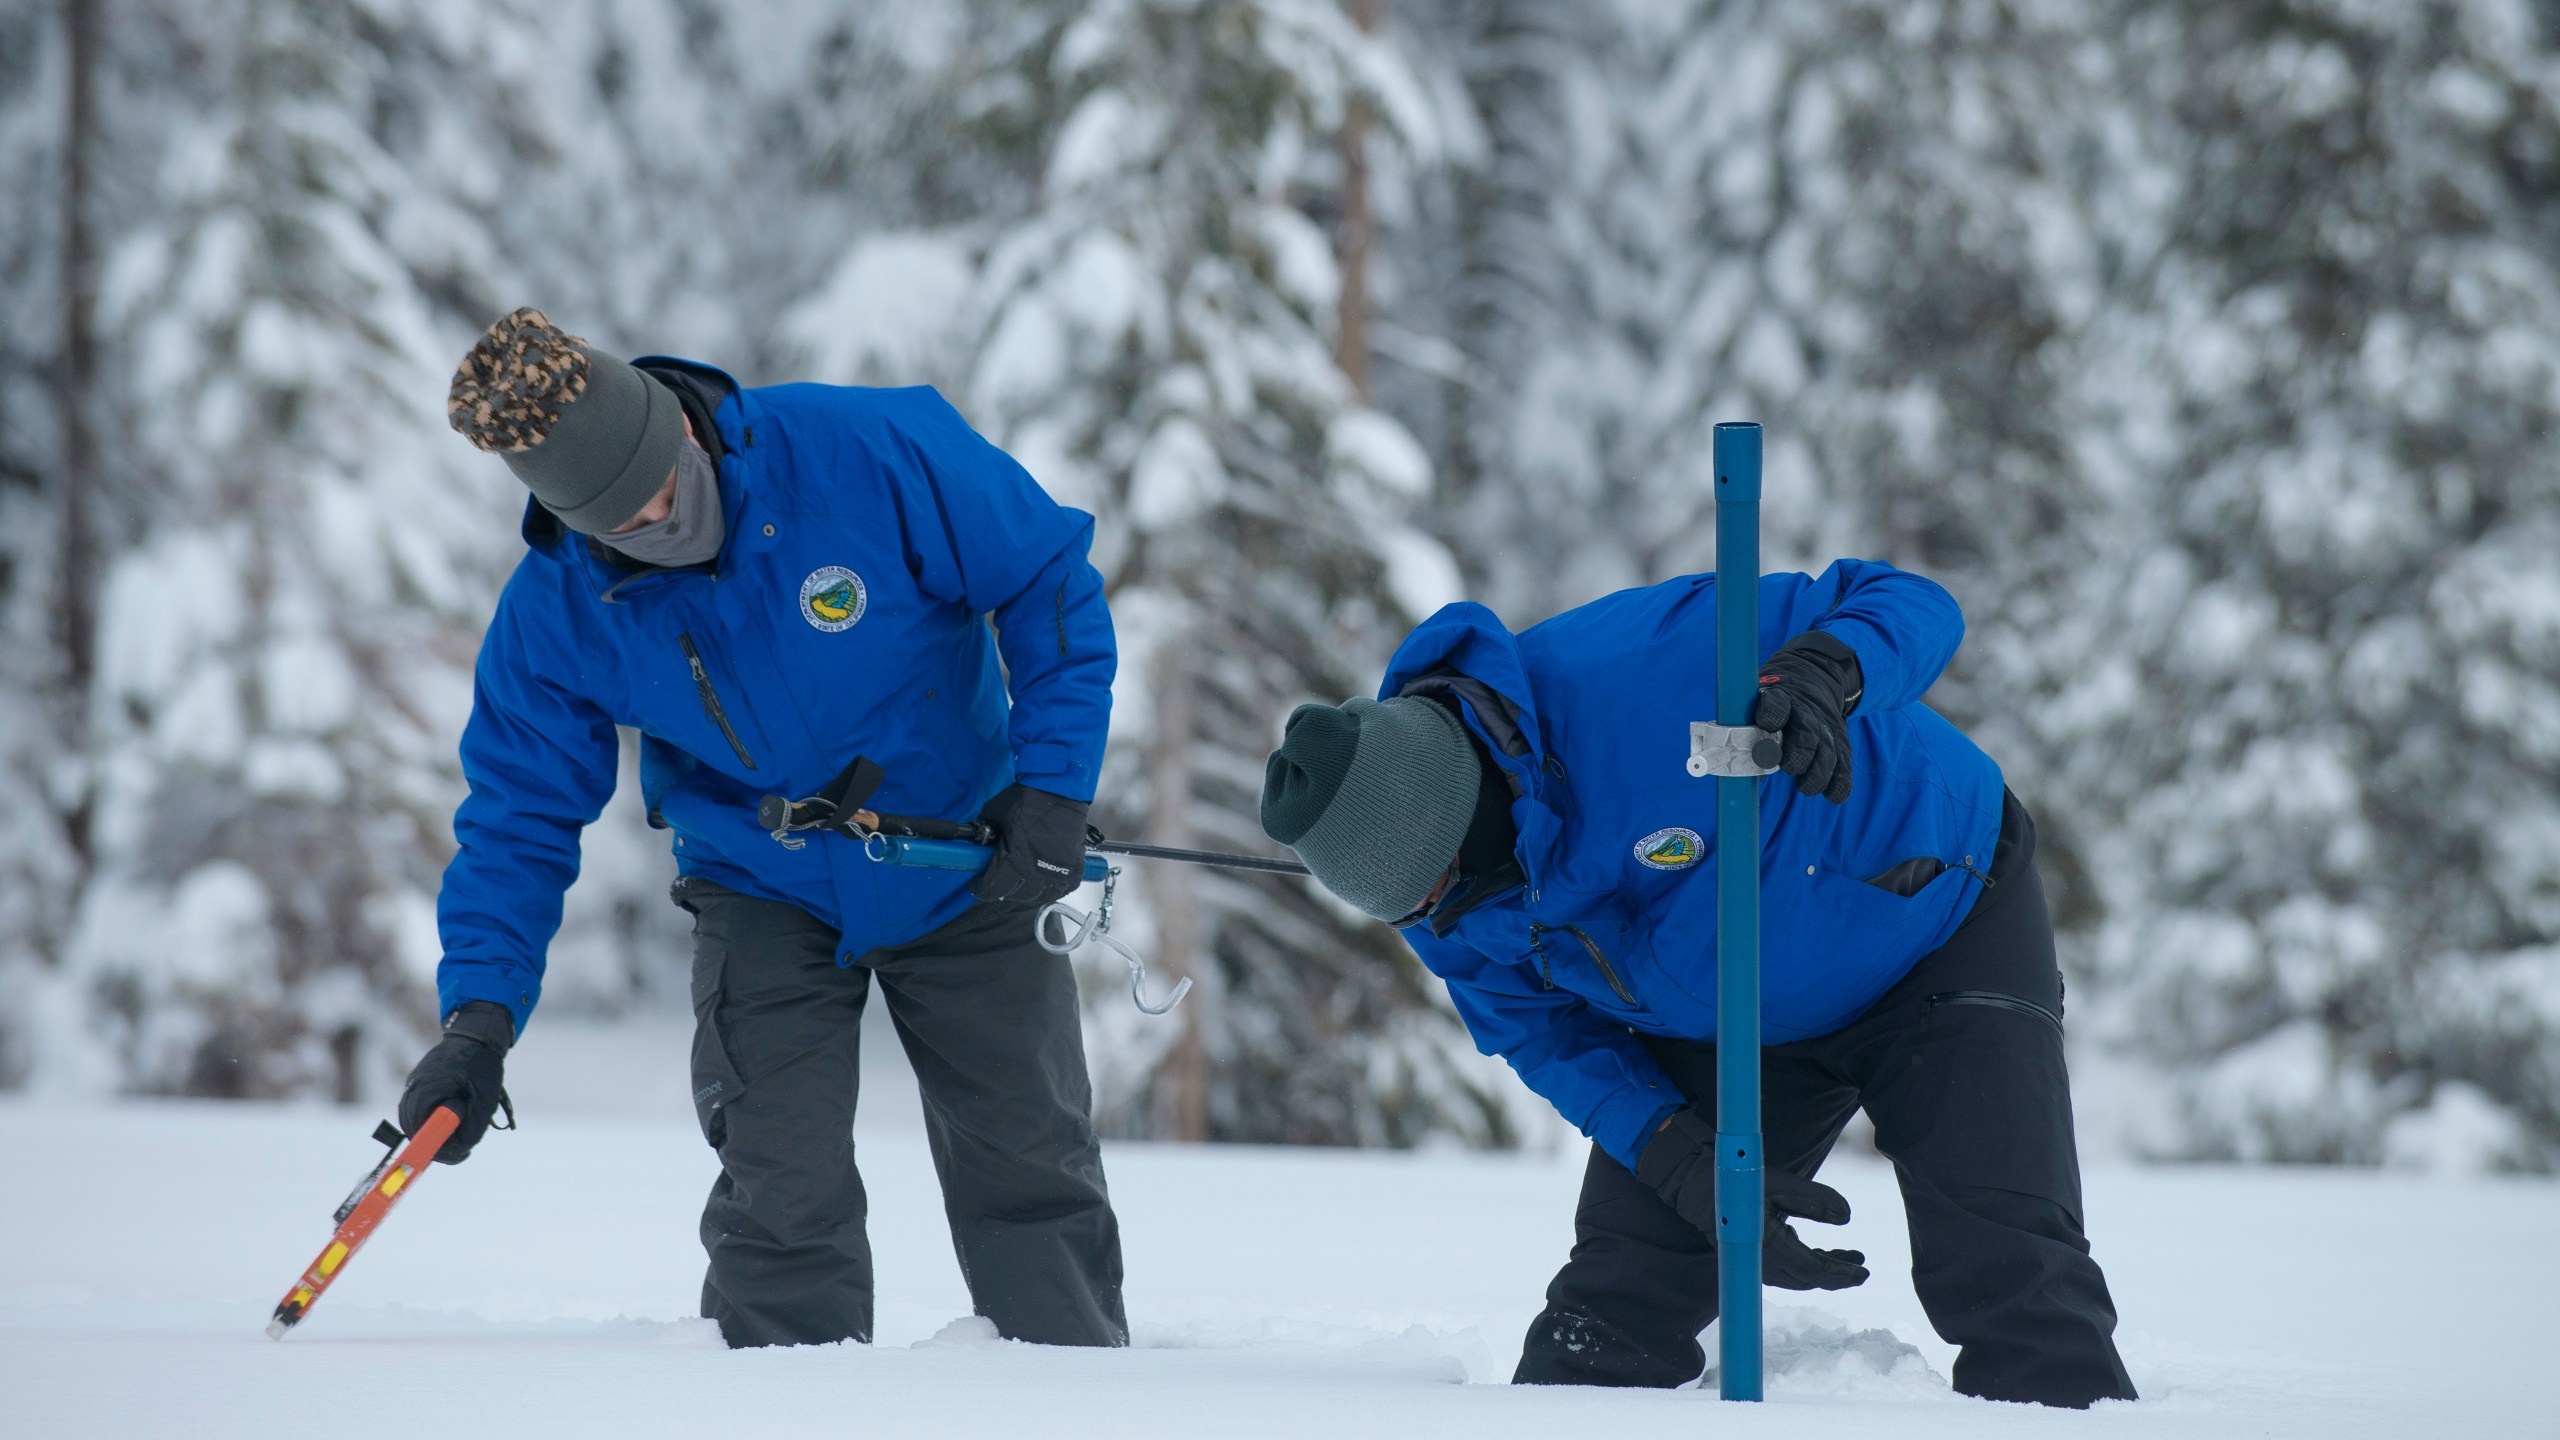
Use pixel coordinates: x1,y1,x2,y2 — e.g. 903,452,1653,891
2076,0,2560,1168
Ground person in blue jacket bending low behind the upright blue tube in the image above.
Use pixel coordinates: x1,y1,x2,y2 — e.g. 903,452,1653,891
1262,561,2135,1407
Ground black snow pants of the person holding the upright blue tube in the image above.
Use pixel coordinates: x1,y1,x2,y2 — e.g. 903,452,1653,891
1513,794,2132,1407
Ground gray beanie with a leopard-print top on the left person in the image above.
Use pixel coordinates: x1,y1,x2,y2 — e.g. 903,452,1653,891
445,310,684,536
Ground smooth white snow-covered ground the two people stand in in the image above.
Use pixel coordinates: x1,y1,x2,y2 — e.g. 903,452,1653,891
0,1004,2560,1440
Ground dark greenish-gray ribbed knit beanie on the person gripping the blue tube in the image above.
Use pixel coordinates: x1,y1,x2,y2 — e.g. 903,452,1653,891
1262,697,1480,920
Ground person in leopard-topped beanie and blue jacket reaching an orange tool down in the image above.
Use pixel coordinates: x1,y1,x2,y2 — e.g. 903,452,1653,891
399,310,1129,1345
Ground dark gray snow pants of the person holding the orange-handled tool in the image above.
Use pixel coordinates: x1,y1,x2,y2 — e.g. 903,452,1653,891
676,876,1129,1348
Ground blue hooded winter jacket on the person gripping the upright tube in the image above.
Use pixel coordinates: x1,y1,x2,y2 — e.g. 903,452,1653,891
1380,561,2002,1168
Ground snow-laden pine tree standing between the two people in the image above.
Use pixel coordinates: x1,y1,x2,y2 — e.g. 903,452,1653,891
794,0,1510,1143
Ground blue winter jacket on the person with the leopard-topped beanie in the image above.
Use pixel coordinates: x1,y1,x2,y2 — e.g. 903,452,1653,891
435,359,1116,1030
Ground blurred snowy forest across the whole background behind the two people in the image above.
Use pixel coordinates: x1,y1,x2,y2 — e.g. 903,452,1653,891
0,0,2560,1171
